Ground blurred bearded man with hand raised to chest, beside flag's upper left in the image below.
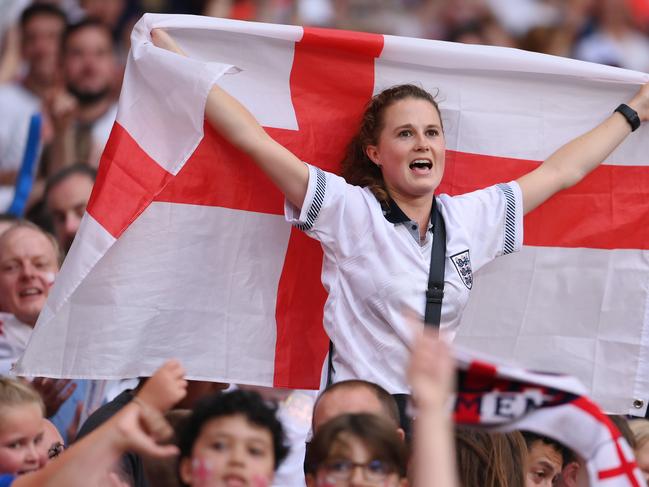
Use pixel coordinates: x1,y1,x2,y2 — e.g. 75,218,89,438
48,19,117,174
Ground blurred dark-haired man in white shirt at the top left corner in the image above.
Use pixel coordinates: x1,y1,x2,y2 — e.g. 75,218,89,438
0,4,67,211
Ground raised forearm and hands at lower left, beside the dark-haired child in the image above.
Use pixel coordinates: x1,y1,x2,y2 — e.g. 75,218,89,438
11,361,187,487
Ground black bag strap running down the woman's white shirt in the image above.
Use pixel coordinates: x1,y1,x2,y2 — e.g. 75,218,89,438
424,198,446,328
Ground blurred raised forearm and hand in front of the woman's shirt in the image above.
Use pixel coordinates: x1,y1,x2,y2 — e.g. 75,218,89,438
408,327,458,487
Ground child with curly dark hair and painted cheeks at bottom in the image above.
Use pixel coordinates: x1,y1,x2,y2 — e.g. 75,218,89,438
178,390,288,487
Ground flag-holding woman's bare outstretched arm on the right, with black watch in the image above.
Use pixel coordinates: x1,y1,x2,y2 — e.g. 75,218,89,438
518,83,649,213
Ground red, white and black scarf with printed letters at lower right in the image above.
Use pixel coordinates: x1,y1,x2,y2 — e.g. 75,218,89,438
454,350,646,487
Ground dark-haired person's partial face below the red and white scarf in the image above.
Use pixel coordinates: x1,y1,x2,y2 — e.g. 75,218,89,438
522,431,575,487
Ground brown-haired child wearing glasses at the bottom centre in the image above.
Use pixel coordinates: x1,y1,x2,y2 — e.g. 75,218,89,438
306,414,408,487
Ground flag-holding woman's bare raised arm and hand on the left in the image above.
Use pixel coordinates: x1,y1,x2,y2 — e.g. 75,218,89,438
151,29,309,208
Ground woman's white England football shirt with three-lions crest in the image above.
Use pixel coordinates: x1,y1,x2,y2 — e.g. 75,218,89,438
285,166,523,394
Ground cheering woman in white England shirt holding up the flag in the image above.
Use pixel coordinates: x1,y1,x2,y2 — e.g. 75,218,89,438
152,29,649,394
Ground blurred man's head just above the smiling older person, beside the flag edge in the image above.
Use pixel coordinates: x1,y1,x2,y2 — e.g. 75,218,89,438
45,164,97,253
